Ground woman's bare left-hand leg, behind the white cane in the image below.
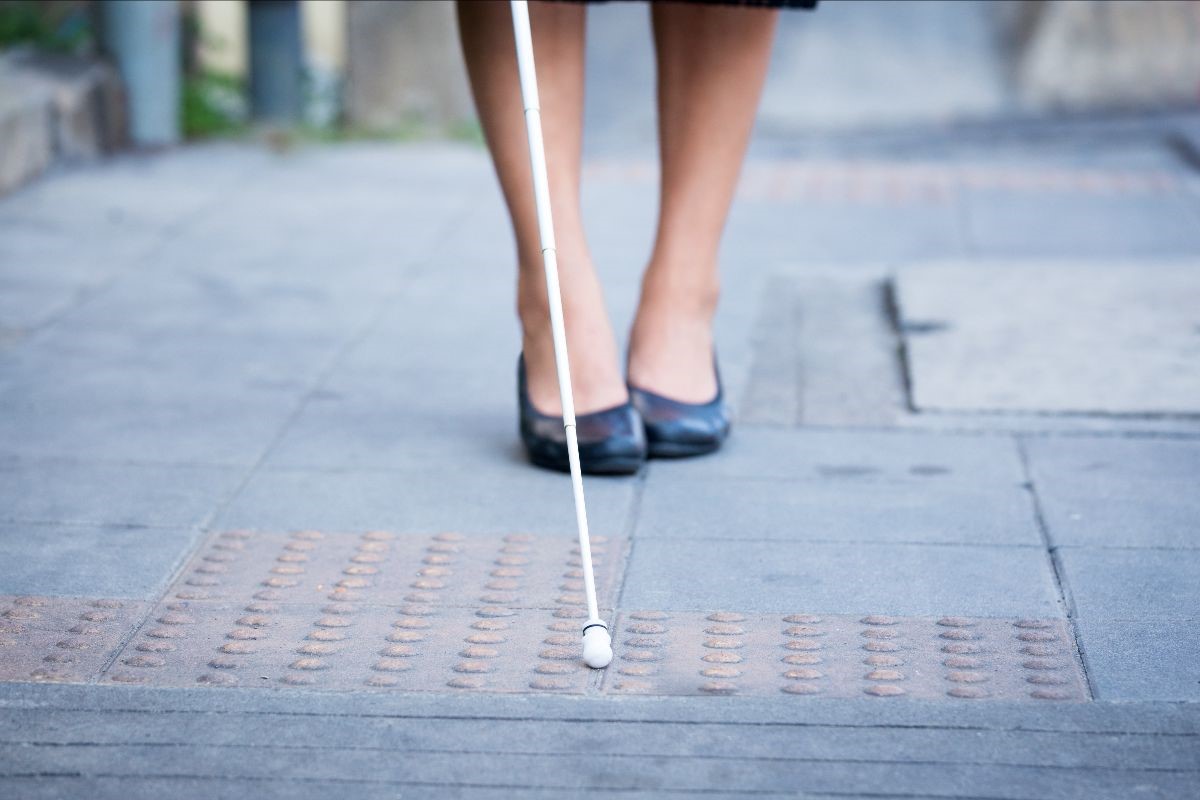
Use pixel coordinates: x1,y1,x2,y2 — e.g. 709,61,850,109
458,1,626,414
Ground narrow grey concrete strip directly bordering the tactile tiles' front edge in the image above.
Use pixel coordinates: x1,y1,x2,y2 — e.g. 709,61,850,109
0,682,1200,738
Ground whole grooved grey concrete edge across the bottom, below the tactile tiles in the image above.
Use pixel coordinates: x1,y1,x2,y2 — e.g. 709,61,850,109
0,684,1200,798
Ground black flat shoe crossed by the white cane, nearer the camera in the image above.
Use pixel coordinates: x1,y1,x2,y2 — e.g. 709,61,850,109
517,356,646,475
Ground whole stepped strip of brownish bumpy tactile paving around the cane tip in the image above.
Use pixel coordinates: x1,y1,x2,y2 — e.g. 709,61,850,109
0,530,1088,702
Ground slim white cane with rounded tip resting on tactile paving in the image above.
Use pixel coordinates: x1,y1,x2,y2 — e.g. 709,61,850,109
512,0,612,669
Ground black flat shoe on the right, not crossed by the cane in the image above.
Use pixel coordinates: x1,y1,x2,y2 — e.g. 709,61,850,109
628,361,730,458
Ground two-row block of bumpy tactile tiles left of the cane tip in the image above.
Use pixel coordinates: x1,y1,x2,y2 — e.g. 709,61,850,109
106,531,624,692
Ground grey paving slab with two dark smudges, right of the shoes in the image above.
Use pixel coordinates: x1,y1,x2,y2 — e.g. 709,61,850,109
649,422,1025,486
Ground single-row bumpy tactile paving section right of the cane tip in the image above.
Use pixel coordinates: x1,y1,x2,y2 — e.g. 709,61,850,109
602,610,1087,700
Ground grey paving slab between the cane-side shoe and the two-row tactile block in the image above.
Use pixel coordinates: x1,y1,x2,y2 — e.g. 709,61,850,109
217,465,636,537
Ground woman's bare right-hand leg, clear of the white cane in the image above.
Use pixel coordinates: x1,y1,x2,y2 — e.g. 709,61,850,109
629,2,779,403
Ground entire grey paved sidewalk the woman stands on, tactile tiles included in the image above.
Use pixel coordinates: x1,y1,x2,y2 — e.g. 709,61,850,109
0,123,1200,799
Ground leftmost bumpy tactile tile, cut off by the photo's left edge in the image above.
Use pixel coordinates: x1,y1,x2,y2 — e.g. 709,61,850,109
0,596,146,682
